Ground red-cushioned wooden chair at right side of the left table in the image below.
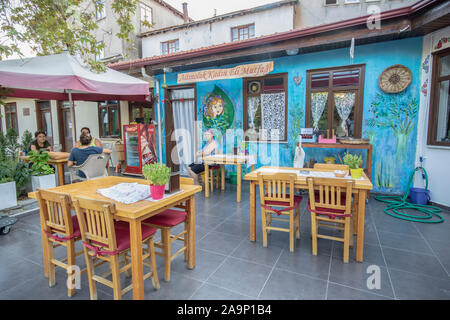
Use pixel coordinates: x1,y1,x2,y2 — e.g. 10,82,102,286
142,177,194,281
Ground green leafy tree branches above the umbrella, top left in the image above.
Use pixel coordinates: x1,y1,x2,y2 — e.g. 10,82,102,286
0,0,150,72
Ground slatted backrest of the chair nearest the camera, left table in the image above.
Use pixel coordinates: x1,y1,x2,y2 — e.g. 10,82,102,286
73,197,117,251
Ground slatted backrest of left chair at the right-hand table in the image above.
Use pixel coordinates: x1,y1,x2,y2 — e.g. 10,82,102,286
258,172,297,206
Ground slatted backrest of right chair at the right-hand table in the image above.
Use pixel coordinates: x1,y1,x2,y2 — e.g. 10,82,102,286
307,178,354,214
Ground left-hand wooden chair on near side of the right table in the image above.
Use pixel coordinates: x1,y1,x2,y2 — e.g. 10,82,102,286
258,172,302,252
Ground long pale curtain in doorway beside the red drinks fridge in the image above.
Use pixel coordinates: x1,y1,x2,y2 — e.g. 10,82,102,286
171,88,195,175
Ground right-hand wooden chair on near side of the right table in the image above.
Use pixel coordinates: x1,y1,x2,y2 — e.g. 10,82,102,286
307,178,353,263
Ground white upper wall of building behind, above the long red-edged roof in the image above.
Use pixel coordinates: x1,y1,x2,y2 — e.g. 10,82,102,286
142,6,294,58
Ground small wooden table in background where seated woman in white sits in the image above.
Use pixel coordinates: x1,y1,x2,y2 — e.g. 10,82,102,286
203,154,255,202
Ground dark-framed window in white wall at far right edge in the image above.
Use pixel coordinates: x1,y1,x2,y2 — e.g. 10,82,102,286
428,49,450,146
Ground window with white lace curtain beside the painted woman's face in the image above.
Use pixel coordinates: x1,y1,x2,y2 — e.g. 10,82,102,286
243,73,288,142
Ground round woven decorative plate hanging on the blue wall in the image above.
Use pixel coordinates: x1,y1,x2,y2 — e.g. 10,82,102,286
378,64,412,93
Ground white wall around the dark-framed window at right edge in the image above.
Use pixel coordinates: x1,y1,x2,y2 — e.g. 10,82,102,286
414,26,450,206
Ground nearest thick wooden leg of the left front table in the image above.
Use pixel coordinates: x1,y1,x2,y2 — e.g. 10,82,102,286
130,220,144,300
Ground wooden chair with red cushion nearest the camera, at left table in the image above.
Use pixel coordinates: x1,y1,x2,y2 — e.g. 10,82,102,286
73,197,159,300
